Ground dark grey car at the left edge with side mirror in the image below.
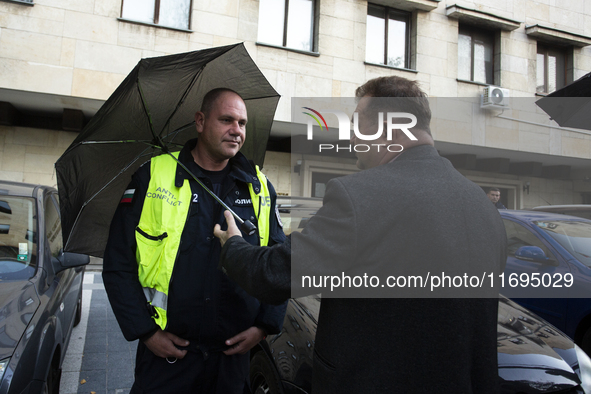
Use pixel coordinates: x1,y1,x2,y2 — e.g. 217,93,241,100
0,181,89,394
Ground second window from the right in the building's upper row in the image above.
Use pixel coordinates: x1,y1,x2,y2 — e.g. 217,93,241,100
458,25,495,84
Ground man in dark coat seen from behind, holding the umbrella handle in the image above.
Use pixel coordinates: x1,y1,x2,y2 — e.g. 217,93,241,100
214,77,506,394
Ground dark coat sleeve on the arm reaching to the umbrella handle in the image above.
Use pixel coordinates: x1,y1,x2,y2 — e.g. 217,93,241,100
220,179,358,303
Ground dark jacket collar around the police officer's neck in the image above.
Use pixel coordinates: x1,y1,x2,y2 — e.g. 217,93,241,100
174,138,260,188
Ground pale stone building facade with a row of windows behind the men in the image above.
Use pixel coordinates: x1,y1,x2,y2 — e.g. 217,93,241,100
0,0,591,208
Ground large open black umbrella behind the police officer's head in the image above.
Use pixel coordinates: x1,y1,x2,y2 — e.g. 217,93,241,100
55,44,279,257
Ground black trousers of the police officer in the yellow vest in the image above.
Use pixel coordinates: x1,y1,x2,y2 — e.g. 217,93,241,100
131,341,250,394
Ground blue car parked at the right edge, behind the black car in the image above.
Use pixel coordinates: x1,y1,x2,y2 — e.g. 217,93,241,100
499,210,591,354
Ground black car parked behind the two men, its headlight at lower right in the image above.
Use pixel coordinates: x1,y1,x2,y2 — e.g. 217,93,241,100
250,197,591,394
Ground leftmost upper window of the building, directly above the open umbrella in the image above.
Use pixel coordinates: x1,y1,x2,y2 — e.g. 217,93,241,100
121,0,191,30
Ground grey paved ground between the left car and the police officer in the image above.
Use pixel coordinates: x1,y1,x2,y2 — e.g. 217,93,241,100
60,271,137,394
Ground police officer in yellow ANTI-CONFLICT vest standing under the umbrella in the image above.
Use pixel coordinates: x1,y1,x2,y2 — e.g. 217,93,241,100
103,89,286,394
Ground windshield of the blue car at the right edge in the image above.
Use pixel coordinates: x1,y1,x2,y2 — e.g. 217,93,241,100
534,220,591,267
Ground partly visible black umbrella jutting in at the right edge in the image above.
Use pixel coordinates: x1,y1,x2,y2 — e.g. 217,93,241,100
536,73,591,130
